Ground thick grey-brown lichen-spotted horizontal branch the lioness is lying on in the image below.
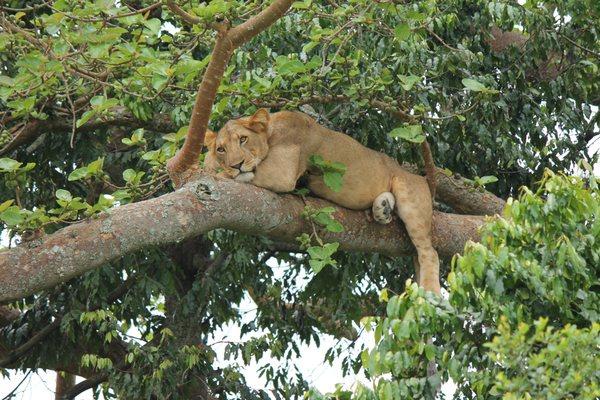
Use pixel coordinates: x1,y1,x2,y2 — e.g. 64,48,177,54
0,175,484,302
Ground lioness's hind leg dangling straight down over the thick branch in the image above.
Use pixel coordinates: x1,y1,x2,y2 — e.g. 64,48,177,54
392,177,440,294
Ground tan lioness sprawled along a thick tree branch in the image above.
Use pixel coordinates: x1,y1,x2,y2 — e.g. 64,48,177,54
205,109,440,293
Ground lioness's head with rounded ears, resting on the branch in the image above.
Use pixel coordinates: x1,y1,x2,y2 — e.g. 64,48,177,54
204,108,269,178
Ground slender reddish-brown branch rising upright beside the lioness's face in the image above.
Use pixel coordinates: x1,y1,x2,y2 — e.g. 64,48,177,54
167,0,293,186
